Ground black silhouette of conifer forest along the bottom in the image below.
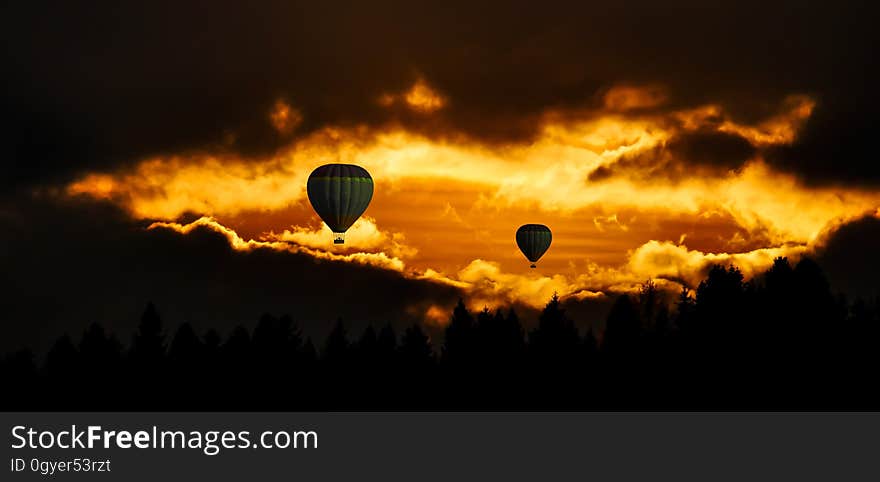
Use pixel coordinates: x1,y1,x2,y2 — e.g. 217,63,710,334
0,258,880,411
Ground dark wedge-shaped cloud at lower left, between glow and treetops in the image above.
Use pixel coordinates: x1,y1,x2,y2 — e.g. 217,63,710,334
0,196,468,352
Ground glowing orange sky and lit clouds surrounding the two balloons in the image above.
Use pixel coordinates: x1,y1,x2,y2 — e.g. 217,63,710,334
66,79,880,310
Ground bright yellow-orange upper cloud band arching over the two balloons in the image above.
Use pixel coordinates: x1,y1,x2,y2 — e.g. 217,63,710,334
67,97,864,249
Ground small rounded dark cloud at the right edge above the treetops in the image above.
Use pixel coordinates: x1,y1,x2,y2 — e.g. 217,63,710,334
817,216,880,298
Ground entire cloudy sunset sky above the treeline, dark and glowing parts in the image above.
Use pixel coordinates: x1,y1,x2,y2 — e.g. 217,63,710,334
0,1,880,352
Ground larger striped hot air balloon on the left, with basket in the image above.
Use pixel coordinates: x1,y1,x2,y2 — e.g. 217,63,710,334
306,164,373,244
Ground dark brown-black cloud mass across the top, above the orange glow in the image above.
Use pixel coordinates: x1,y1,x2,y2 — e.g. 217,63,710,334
0,0,880,187
